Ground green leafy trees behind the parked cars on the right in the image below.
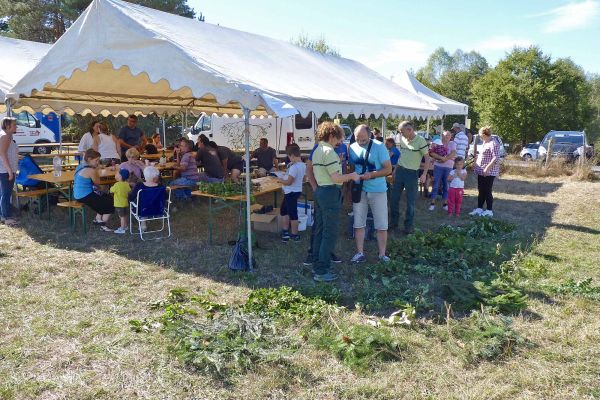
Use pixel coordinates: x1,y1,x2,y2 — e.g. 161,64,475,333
416,46,600,144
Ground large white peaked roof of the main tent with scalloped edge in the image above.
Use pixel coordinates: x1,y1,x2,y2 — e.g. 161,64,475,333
3,0,439,117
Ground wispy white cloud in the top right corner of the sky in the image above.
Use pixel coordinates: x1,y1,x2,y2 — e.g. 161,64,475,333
538,0,600,33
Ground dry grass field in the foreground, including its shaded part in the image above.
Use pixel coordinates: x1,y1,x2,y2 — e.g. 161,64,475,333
0,175,600,399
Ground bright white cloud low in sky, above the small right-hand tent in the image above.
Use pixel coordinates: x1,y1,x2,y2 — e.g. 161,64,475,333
365,39,431,77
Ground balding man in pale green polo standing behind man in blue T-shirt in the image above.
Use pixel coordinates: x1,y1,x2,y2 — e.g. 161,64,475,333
390,121,429,234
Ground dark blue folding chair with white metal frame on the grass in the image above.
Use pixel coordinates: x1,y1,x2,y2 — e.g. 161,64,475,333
129,186,171,240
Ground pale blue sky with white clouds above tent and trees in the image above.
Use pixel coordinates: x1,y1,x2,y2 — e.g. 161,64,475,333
188,0,600,77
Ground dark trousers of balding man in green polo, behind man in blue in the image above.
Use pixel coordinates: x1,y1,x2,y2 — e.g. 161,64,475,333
390,166,419,229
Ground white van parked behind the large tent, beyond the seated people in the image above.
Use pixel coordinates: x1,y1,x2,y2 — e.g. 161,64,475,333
187,113,317,156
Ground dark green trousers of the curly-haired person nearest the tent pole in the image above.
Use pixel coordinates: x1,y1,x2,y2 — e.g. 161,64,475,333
312,185,342,275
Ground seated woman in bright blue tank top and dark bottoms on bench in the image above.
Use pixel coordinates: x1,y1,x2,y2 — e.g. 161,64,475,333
73,149,115,232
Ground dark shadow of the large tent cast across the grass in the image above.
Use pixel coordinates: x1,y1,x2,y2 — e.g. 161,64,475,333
21,175,559,313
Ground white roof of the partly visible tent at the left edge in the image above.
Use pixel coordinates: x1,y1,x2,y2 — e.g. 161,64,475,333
0,36,50,112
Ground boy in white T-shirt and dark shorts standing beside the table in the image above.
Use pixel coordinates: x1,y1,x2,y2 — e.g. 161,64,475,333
277,143,306,242
